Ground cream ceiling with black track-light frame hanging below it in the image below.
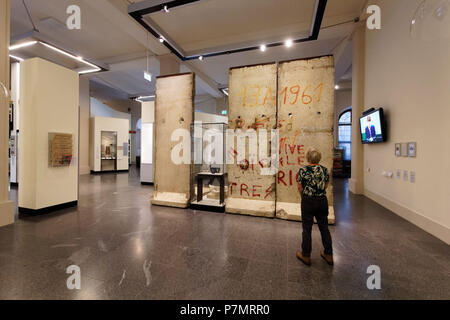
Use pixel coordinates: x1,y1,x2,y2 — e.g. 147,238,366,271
11,0,366,104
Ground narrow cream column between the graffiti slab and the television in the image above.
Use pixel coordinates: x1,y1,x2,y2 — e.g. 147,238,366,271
348,22,366,194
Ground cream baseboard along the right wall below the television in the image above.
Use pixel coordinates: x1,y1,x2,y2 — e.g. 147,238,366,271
364,189,450,244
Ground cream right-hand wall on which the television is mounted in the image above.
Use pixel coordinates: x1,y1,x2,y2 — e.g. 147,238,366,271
364,0,450,243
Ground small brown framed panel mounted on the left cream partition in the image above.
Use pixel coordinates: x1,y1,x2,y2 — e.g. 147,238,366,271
48,132,73,167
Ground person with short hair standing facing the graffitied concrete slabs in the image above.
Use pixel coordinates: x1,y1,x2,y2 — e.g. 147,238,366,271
296,149,334,266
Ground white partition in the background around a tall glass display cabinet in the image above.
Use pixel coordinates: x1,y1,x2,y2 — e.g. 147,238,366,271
90,117,130,172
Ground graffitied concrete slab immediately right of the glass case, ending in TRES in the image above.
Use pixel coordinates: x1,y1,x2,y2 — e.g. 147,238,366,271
226,63,277,217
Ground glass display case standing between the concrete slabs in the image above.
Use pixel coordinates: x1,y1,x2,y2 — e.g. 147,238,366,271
190,122,228,212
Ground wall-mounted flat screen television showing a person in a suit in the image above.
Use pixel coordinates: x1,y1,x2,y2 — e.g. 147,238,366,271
359,108,387,144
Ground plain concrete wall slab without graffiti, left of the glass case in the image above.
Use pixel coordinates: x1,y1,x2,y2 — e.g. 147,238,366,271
151,73,195,208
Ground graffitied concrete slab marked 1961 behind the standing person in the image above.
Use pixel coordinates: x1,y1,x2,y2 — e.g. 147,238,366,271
276,56,334,223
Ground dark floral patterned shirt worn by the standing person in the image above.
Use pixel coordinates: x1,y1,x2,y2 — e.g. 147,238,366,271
297,165,330,197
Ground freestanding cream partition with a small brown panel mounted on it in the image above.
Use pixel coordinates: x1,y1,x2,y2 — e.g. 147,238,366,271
19,58,79,210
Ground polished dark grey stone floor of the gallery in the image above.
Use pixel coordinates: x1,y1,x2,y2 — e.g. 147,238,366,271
0,171,450,299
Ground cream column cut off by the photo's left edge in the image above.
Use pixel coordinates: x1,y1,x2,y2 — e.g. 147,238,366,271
0,0,14,227
